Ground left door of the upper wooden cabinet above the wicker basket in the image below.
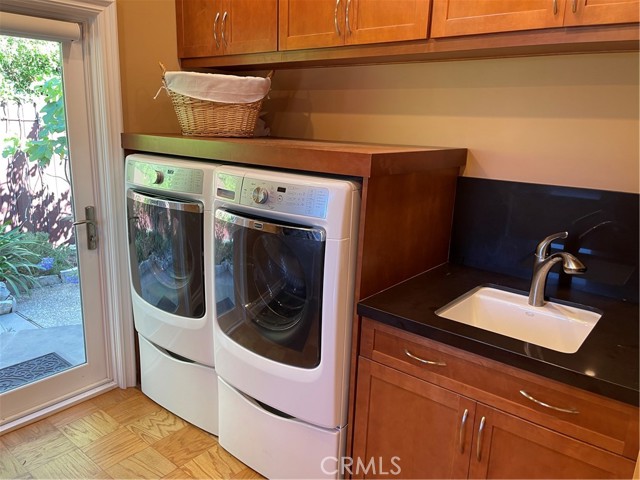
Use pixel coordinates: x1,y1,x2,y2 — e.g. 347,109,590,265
176,0,219,58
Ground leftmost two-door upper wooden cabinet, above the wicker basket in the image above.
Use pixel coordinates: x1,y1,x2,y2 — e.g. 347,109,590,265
176,0,278,58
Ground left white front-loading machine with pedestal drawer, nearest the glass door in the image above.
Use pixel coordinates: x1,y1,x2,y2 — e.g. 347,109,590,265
125,154,218,435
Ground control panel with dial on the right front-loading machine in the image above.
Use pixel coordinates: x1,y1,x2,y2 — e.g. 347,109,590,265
216,172,329,218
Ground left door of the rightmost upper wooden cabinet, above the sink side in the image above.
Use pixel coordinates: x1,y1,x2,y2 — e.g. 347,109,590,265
431,0,566,37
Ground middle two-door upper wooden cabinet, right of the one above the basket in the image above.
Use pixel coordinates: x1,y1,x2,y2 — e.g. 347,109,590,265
279,0,430,50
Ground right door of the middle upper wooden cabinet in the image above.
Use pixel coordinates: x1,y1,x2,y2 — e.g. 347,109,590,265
345,0,430,45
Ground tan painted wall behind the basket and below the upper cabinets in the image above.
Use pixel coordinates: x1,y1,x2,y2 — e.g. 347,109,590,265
117,0,640,193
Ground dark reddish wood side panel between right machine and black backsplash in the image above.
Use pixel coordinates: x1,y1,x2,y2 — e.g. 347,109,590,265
359,168,458,298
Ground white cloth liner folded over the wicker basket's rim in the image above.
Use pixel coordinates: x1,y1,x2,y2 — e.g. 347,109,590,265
164,72,271,103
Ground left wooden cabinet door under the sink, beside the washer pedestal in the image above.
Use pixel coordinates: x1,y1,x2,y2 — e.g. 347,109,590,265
345,357,476,478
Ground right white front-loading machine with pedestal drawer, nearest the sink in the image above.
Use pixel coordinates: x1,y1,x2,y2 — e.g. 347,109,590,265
214,166,361,478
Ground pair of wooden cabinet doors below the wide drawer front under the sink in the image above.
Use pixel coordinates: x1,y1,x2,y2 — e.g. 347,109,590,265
351,320,637,478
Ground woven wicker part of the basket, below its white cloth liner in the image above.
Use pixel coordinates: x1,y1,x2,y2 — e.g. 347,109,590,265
161,65,273,137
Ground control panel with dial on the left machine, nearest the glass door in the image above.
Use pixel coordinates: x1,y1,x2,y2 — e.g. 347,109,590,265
126,160,204,194
